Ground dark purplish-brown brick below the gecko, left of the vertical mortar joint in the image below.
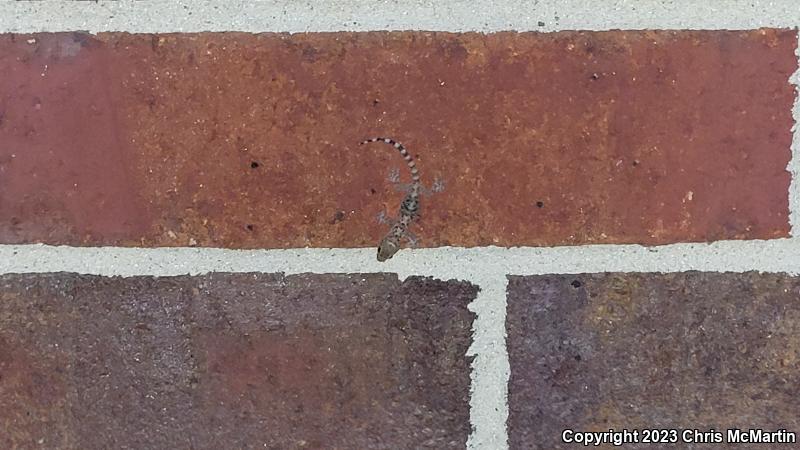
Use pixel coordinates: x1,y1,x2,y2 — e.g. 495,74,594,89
0,274,476,449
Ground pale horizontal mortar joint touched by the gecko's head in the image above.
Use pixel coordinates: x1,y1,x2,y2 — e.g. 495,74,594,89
0,238,800,281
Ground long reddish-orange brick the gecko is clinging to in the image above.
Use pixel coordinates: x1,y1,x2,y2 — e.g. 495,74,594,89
0,29,797,248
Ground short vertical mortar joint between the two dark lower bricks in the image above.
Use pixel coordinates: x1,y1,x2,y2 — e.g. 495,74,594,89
467,270,510,450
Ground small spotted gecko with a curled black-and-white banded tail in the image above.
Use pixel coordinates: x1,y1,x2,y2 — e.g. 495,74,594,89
360,137,444,262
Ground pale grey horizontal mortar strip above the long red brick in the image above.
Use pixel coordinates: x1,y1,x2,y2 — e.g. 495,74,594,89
0,0,800,33
